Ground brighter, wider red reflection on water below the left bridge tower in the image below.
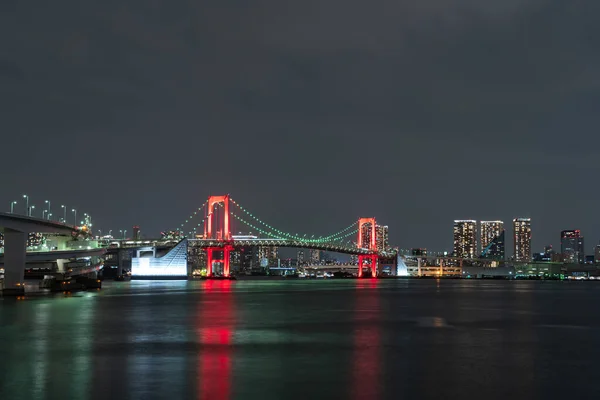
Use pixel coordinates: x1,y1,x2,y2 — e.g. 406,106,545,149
196,280,235,400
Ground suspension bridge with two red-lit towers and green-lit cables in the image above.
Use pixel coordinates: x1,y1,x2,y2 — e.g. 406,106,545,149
178,195,396,277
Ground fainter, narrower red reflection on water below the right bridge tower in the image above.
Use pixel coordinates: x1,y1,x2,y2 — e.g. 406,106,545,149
352,279,381,400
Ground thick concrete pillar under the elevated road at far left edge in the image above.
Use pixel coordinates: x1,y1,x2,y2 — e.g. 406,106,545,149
3,228,29,295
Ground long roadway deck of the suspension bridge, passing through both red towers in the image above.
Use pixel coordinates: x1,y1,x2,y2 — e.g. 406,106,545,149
109,239,397,257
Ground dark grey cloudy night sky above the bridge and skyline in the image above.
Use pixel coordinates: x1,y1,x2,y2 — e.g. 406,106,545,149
0,0,600,254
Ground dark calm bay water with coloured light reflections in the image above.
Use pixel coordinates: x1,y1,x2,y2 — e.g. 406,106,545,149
0,280,600,400
